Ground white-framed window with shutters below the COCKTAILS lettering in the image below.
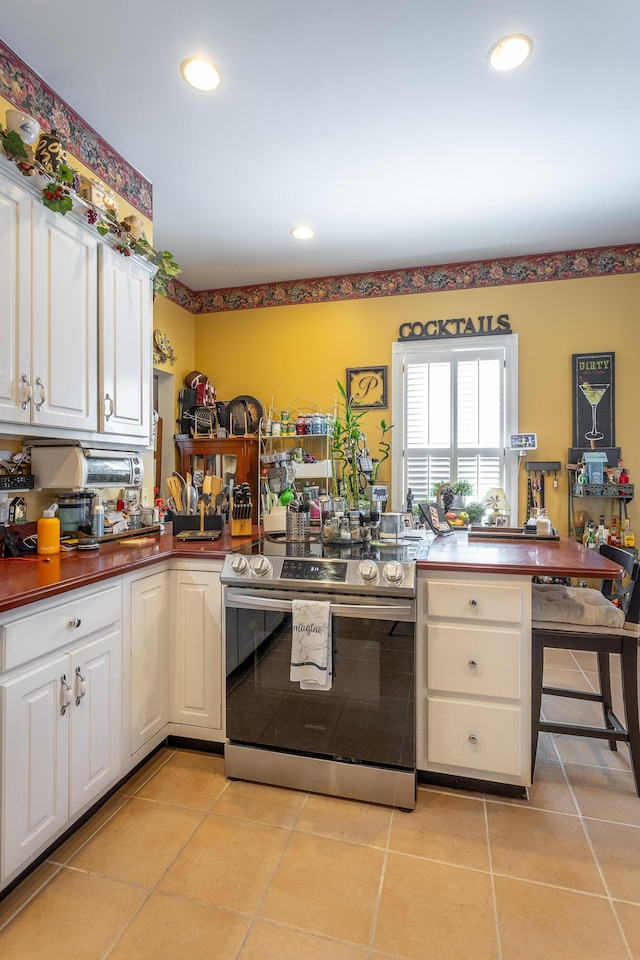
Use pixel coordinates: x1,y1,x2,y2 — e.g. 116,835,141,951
392,334,518,516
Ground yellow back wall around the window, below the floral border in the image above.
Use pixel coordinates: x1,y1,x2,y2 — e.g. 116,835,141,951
192,274,640,532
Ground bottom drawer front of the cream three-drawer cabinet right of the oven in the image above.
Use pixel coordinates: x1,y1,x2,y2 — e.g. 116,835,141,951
427,698,522,779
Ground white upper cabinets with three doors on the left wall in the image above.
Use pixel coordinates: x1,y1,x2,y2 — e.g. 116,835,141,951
0,165,155,448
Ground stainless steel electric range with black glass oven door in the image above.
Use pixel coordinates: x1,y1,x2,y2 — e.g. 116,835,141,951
221,535,428,809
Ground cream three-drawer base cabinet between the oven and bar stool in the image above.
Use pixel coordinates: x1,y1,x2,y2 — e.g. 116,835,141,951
416,571,531,785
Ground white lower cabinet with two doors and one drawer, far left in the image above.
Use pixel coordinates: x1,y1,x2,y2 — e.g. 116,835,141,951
0,584,122,883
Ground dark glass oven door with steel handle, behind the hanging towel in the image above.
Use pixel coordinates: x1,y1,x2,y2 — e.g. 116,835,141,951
225,587,415,770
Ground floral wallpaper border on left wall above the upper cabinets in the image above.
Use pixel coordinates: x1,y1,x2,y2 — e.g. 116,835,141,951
0,40,153,220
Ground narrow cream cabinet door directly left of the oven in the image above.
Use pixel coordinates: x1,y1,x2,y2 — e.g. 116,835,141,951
170,561,225,741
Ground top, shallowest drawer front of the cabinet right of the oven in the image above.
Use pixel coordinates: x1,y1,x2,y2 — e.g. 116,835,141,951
427,580,522,623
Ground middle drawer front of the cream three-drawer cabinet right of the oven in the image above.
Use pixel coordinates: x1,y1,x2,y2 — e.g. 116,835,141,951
425,623,522,700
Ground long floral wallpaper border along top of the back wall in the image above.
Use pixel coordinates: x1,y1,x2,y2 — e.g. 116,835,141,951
167,244,640,314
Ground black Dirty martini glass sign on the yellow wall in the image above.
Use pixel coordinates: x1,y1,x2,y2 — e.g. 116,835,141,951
571,353,616,450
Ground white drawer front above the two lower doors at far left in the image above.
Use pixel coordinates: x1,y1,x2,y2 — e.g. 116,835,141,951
0,583,121,673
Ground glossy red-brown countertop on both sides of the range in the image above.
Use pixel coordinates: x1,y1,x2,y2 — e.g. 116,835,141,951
0,527,620,613
